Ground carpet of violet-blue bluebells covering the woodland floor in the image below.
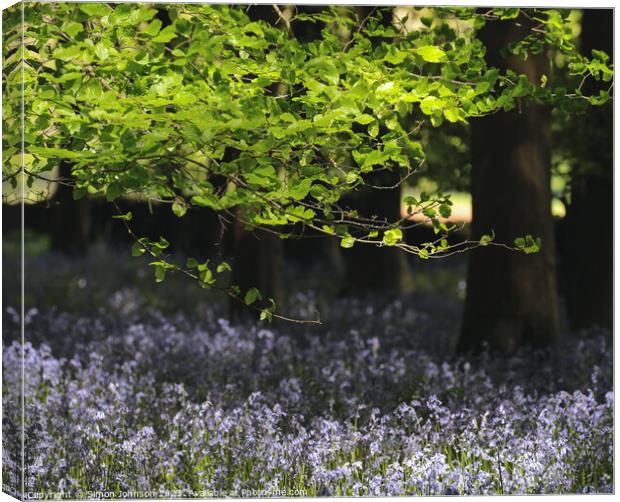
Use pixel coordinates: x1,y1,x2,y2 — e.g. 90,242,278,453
3,247,614,497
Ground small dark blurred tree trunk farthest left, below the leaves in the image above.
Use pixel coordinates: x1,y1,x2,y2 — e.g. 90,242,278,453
49,161,91,255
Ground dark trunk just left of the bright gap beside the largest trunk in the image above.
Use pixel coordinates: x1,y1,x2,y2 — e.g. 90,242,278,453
342,6,412,294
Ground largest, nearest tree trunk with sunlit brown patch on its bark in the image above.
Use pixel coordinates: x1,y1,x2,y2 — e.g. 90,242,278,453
458,16,558,353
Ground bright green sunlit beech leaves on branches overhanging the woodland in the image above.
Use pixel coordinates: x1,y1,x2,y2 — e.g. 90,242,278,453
3,3,612,319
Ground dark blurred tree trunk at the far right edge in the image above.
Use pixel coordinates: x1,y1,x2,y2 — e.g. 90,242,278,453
564,9,614,330
